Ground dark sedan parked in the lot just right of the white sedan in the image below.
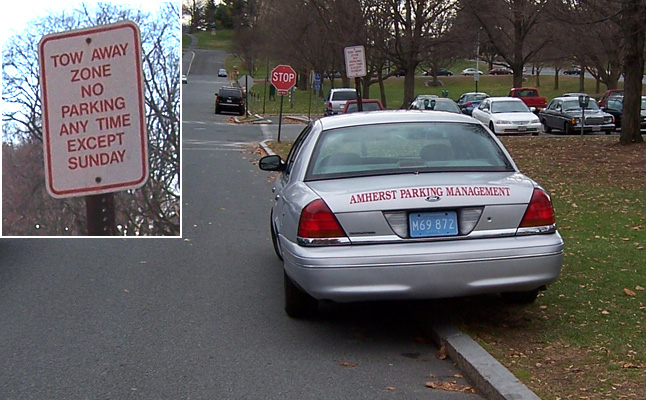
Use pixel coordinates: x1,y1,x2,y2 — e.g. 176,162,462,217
538,97,615,135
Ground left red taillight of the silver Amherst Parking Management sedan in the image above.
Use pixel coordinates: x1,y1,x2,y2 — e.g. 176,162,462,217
298,199,347,241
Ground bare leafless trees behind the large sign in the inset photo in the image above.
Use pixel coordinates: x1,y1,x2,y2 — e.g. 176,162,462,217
2,3,181,236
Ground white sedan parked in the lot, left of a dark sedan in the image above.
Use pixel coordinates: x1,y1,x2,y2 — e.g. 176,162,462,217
472,97,541,135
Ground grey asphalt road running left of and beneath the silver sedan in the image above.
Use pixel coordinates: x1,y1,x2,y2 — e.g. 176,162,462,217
0,48,480,399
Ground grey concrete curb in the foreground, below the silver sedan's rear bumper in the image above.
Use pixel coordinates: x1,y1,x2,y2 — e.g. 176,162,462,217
427,322,540,400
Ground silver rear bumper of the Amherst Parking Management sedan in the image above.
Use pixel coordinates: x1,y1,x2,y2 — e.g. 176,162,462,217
281,233,563,302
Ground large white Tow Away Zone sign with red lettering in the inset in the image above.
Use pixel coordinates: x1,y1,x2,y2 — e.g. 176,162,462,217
39,21,148,198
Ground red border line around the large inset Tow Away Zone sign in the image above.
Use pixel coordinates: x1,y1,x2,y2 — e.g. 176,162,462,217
38,21,149,198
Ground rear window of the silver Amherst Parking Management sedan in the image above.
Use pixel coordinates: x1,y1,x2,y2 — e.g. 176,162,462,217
305,122,514,181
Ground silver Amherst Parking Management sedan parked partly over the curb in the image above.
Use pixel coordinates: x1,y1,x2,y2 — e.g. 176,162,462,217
259,110,563,318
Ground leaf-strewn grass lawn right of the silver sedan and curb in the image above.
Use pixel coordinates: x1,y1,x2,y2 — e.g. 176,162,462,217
264,136,646,399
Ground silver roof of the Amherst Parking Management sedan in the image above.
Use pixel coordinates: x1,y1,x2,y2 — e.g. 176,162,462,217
316,110,479,130
